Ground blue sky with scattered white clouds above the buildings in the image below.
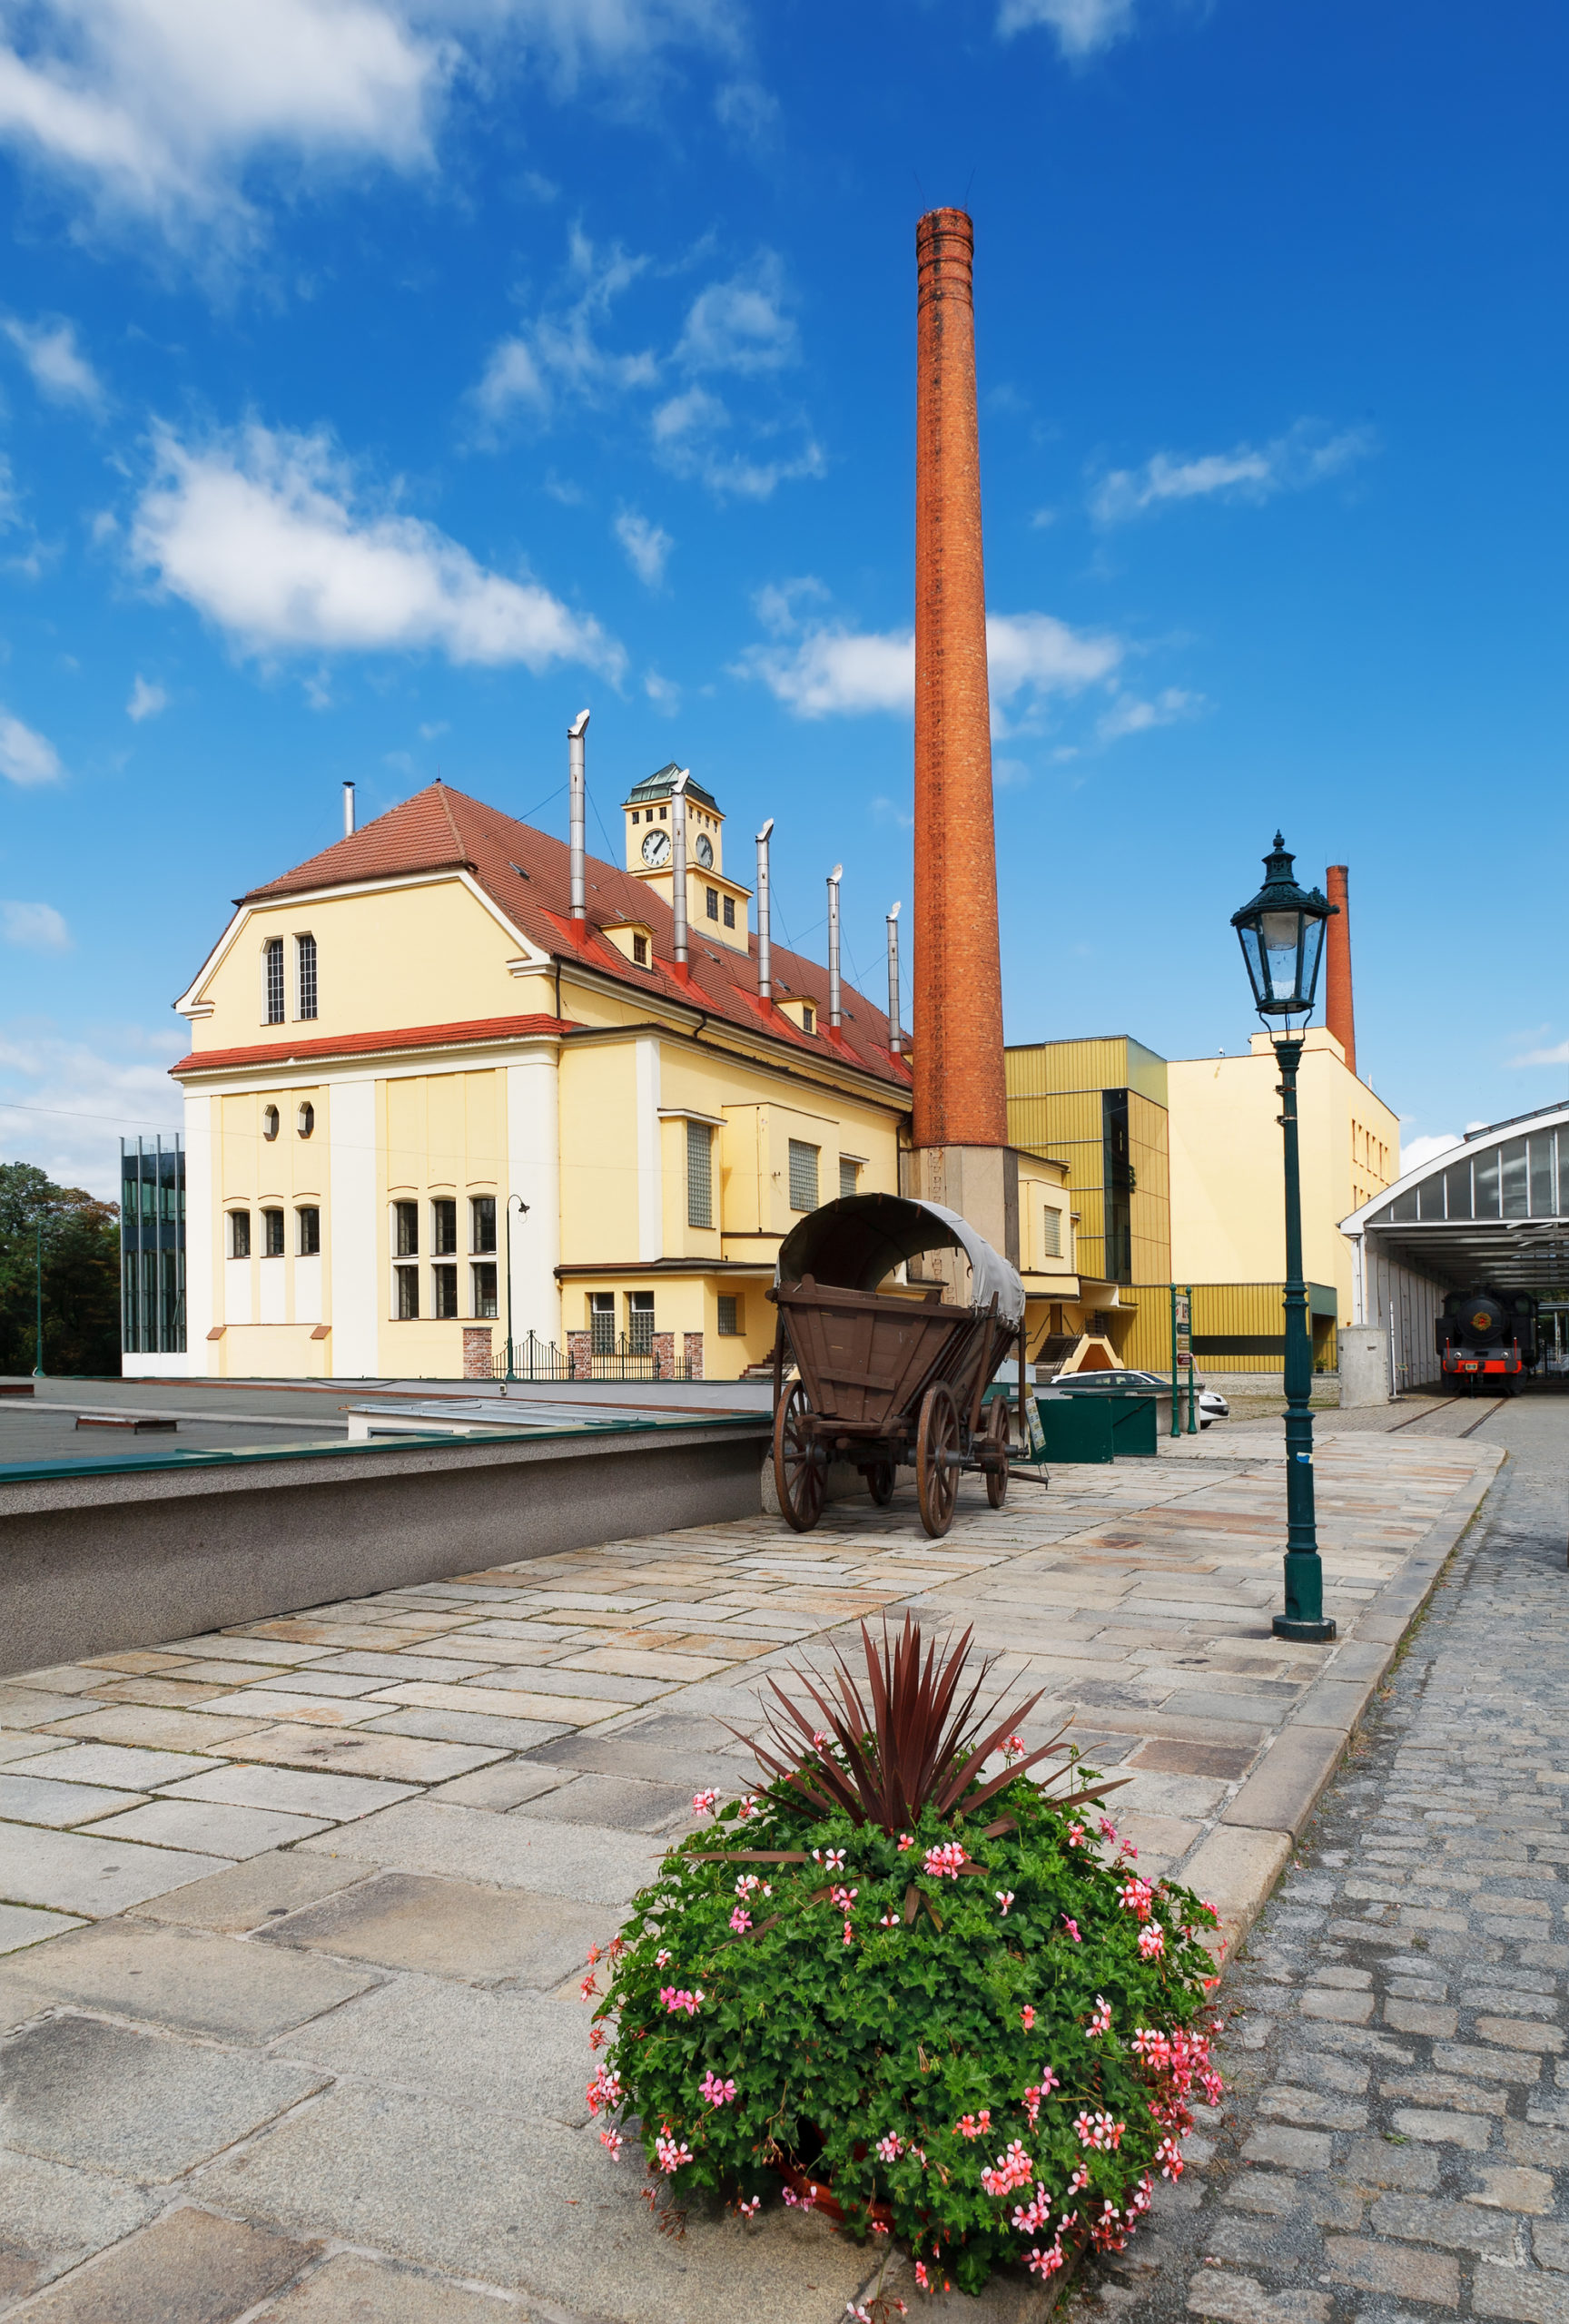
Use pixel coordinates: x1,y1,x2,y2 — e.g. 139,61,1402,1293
0,0,1569,1190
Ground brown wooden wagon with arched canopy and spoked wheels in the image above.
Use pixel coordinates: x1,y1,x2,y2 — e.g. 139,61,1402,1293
769,1195,1025,1536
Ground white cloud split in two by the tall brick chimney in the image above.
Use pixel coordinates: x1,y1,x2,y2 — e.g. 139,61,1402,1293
737,608,1125,718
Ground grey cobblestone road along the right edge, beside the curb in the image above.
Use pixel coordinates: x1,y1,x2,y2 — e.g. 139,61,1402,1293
1070,1399,1569,2324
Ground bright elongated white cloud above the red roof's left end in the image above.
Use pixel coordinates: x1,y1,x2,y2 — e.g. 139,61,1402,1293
133,425,626,679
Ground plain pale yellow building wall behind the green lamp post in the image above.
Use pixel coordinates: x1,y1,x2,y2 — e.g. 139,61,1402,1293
1167,1025,1399,1324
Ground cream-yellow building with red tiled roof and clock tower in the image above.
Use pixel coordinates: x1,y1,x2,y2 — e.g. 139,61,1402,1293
163,767,924,1378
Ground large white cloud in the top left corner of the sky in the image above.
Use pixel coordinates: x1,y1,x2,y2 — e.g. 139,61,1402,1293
0,0,737,244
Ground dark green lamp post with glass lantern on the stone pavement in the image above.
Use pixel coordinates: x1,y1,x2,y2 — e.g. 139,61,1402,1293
1232,832,1337,1645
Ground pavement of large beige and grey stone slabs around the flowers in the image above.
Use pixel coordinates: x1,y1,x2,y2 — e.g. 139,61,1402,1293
0,1432,1505,2324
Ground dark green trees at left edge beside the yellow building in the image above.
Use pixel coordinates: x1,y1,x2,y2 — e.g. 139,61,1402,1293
0,1162,121,1378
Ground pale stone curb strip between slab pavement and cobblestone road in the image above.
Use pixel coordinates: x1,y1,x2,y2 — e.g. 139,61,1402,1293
1174,1450,1506,1955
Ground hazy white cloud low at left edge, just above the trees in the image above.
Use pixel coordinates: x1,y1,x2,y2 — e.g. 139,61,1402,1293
0,1018,188,1202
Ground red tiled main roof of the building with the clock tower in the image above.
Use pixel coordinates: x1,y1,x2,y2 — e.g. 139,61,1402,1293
224,783,909,1090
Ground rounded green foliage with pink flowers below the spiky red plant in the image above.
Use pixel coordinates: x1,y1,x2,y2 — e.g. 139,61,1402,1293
590,1773,1220,2291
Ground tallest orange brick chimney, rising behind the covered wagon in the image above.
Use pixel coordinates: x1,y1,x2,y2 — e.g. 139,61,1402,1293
912,209,1018,1257
